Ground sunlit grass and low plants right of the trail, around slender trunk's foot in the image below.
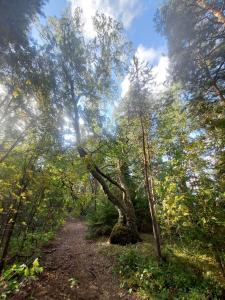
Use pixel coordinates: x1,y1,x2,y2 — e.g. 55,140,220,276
97,234,225,300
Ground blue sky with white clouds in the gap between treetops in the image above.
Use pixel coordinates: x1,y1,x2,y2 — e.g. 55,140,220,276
35,0,169,95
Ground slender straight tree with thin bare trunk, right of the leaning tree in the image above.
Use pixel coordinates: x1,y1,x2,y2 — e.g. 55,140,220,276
120,57,162,260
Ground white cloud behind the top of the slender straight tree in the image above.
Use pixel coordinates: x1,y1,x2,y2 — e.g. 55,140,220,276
121,44,169,97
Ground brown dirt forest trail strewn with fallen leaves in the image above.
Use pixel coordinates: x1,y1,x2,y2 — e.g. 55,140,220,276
12,220,138,300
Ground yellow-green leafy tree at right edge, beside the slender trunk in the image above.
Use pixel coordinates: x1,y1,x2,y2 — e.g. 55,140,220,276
153,93,225,275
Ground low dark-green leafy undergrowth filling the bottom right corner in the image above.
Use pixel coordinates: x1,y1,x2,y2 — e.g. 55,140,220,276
115,249,223,300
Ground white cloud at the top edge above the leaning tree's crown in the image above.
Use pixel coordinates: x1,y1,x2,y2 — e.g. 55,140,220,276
68,0,144,37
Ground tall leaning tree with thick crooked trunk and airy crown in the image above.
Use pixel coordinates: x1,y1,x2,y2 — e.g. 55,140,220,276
39,9,140,243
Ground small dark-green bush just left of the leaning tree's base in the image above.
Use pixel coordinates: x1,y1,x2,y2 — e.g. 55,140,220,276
87,199,118,237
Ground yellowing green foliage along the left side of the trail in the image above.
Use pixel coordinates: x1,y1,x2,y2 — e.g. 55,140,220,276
0,141,75,270
